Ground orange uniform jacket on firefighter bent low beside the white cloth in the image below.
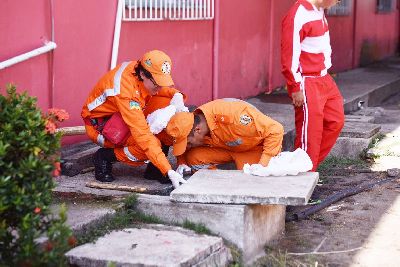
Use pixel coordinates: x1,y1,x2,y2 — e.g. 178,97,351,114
198,99,283,166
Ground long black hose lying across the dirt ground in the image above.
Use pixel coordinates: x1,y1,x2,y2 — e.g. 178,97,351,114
285,177,398,222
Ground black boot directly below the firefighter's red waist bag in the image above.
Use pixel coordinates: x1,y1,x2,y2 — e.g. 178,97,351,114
93,148,117,183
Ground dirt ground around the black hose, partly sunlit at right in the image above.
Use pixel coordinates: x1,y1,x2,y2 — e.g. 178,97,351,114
255,94,400,267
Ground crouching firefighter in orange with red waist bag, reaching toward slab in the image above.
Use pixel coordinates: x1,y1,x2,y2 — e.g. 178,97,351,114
81,50,185,187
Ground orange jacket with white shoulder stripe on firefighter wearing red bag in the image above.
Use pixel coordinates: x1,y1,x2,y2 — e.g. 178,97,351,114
81,61,179,174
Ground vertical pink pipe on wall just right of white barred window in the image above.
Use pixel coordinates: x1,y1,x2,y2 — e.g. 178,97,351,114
211,0,220,100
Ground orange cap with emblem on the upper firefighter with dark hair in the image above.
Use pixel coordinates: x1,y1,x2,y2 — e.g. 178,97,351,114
141,50,174,86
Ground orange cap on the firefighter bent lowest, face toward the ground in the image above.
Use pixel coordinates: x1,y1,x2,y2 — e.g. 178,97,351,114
167,112,194,156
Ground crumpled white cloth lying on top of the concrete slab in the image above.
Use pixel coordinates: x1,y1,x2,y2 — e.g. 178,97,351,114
243,148,313,176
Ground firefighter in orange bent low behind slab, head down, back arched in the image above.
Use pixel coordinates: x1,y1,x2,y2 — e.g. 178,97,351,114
167,98,283,174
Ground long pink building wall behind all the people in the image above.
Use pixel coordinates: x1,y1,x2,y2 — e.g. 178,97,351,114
0,0,399,146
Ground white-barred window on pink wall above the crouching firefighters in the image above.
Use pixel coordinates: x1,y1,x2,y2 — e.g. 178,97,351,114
122,0,214,21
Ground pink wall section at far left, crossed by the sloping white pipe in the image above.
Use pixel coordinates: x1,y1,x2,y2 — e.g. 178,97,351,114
0,0,51,108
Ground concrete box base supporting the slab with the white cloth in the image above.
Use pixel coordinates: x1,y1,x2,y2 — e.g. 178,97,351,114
136,194,286,263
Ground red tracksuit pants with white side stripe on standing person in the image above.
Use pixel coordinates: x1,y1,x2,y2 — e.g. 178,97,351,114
295,74,344,171
